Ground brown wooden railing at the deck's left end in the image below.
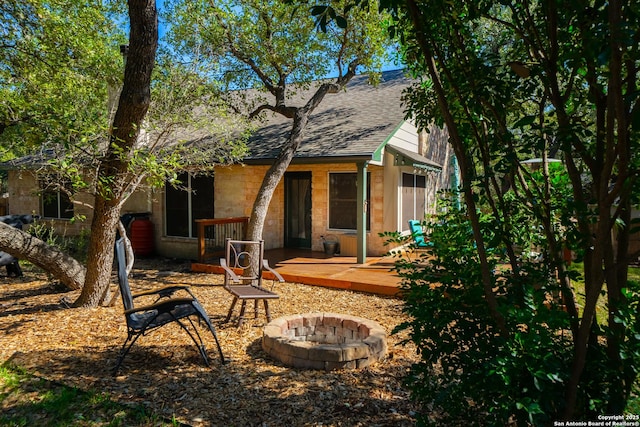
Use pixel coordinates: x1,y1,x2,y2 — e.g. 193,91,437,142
196,217,249,263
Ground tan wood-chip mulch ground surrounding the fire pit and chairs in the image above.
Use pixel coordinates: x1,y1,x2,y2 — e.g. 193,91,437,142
0,259,418,427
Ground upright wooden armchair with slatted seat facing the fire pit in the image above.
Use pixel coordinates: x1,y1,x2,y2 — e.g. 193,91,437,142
220,239,284,327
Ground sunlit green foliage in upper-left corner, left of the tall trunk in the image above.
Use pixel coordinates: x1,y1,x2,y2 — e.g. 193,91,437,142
0,0,125,160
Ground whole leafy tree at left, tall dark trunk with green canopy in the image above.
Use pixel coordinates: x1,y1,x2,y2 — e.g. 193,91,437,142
0,0,246,305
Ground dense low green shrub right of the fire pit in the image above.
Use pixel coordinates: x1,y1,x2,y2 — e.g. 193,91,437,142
385,199,638,426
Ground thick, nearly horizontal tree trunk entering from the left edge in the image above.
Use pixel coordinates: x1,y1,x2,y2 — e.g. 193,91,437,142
0,221,85,290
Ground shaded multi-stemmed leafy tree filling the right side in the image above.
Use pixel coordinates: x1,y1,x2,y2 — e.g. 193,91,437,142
395,0,640,424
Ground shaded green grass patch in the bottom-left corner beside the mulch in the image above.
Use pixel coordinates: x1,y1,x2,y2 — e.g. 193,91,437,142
0,363,180,426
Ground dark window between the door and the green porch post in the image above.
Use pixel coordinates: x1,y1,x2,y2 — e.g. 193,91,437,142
329,173,371,230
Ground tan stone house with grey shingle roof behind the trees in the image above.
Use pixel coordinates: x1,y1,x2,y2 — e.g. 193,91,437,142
5,71,453,262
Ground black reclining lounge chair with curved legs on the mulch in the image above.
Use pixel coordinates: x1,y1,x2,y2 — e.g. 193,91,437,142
113,238,224,375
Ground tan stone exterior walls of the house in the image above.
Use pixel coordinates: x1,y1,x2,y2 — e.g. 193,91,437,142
9,163,420,260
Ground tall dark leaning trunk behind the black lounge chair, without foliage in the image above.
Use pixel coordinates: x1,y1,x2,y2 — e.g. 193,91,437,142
74,0,158,307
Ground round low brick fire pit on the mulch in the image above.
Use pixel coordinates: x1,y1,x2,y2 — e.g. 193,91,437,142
262,313,387,371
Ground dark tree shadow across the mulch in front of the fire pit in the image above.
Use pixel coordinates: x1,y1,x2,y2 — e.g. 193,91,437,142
10,340,415,426
